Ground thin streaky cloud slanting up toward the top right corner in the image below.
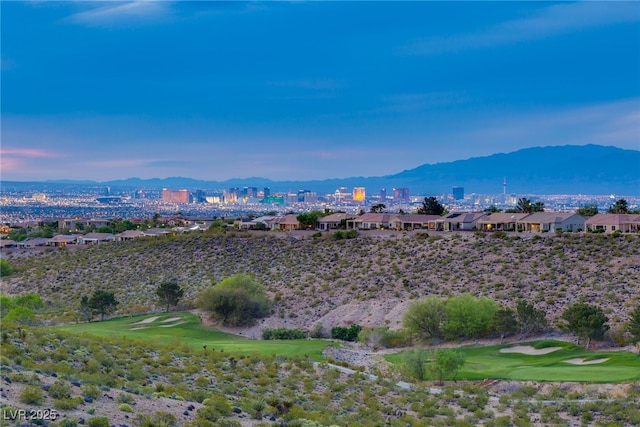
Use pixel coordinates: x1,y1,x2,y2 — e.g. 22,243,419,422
399,2,640,55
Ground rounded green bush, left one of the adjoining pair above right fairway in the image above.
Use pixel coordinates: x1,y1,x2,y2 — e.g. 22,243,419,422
402,296,447,339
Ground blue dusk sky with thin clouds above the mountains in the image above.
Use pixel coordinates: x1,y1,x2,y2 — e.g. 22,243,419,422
0,1,640,181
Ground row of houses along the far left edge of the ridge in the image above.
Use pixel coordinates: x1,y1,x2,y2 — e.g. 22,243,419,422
0,224,206,249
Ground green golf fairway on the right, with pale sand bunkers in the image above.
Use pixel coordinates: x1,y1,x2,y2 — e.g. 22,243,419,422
386,340,640,383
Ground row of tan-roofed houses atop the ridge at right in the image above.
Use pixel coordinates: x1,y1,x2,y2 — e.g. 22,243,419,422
236,212,640,233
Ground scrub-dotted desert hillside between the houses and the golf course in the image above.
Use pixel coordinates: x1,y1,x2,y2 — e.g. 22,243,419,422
2,232,640,334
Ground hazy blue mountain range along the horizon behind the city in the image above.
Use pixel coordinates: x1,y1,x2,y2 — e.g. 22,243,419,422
5,145,640,196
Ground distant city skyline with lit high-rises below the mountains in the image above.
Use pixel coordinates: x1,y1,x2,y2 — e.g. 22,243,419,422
0,179,640,227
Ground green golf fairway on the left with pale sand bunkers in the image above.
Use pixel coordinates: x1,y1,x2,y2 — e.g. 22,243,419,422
59,312,333,361
